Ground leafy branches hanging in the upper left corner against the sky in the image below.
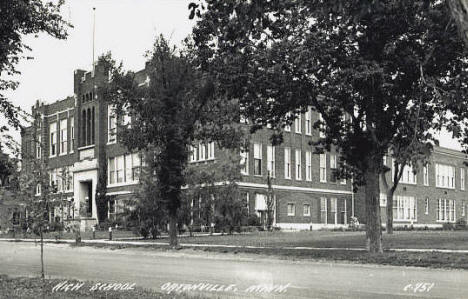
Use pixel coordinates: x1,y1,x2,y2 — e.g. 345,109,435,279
0,0,70,131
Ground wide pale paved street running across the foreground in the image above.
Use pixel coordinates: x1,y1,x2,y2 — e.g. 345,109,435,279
0,242,468,298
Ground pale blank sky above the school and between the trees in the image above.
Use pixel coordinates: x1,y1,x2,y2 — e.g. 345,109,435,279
2,0,460,149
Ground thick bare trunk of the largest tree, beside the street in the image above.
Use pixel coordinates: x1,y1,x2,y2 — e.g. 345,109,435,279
364,157,383,253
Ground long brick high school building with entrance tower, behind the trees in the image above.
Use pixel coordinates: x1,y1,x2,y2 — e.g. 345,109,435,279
22,61,466,229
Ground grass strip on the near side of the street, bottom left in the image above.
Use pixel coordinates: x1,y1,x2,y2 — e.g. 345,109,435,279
0,275,201,299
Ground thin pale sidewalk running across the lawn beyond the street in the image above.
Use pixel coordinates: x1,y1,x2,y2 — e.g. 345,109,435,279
0,238,468,254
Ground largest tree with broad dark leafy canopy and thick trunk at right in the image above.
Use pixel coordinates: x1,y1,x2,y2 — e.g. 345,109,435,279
190,0,468,252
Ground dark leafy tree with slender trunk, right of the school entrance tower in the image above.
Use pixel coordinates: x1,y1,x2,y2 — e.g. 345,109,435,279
103,36,240,247
